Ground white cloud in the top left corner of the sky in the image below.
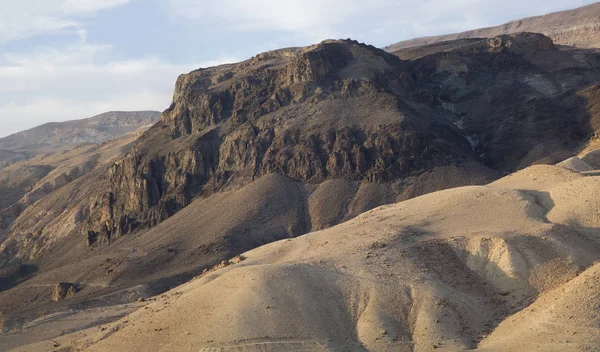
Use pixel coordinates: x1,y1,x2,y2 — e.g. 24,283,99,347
0,0,132,43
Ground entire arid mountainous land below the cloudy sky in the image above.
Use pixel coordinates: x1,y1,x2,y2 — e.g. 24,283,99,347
0,4,600,352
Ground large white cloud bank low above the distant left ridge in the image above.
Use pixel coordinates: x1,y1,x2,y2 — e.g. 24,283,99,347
0,39,236,136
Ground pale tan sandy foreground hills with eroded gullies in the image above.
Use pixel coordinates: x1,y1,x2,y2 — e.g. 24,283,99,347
28,166,600,351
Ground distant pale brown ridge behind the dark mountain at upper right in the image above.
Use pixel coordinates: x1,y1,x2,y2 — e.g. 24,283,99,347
385,3,600,52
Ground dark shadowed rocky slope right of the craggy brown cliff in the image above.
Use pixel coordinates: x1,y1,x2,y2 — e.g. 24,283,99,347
413,33,600,170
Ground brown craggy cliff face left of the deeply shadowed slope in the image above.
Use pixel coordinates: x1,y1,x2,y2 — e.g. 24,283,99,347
81,41,482,243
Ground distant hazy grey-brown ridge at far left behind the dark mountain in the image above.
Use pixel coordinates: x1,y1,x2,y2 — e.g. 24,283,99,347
0,111,160,168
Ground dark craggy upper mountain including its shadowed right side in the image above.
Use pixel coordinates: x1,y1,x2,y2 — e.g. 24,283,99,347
77,34,600,243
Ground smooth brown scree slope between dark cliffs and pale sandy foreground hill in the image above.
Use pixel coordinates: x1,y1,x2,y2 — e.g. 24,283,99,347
0,168,492,346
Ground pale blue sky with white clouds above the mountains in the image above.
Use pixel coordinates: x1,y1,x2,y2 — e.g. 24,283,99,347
0,0,595,137
